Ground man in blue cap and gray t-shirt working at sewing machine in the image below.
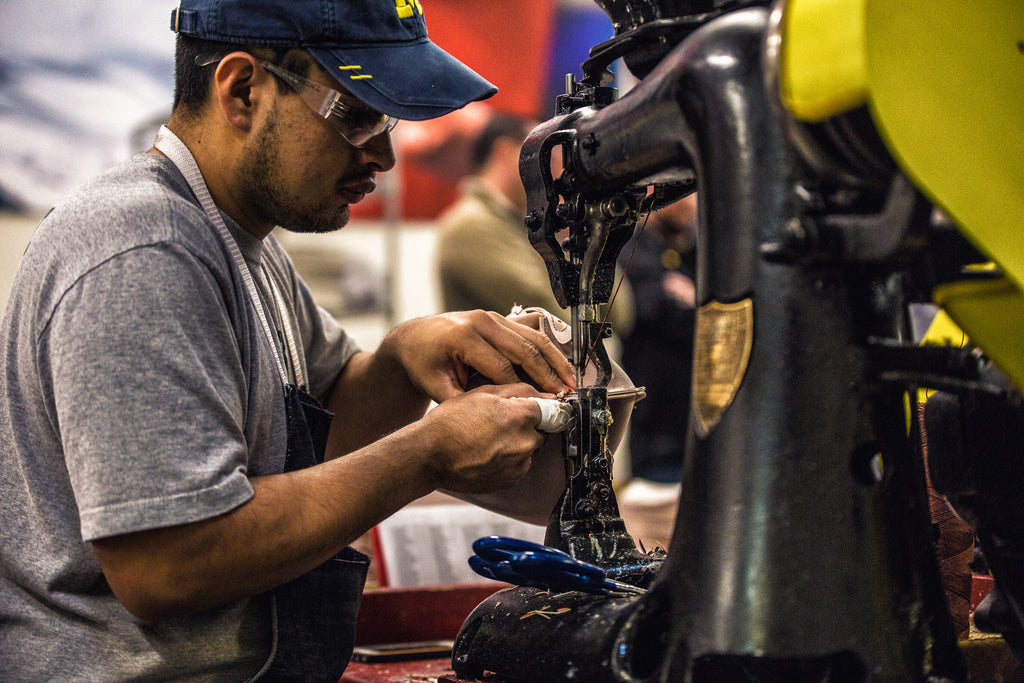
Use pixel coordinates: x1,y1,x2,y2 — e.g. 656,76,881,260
0,0,572,681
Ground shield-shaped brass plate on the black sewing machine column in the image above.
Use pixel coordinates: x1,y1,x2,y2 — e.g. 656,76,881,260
693,298,754,436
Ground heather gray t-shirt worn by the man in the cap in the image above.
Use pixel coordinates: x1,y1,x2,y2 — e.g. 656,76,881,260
0,155,356,681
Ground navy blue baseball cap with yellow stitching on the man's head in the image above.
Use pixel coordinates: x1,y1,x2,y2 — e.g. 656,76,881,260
171,0,498,121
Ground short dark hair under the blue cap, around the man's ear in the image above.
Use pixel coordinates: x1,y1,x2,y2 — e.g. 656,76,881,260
173,34,313,116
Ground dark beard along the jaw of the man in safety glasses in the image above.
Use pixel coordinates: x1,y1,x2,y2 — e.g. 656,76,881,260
239,110,350,233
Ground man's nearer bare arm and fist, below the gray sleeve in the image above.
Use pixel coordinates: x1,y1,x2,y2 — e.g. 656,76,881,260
93,383,550,622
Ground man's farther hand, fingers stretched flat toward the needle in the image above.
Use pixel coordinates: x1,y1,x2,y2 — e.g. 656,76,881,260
377,310,575,403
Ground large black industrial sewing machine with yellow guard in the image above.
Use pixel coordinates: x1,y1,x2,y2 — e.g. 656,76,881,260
453,0,1024,683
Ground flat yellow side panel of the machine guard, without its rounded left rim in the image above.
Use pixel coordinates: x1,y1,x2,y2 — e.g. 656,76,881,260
865,0,1024,387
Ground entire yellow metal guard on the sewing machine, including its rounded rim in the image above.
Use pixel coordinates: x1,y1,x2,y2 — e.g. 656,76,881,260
779,0,1024,388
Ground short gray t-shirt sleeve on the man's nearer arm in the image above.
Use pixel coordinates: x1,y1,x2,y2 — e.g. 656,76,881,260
45,244,253,541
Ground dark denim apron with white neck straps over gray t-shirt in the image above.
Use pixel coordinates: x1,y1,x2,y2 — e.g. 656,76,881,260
156,127,370,683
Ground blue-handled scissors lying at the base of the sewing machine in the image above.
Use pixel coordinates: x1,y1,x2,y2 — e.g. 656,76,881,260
469,536,644,594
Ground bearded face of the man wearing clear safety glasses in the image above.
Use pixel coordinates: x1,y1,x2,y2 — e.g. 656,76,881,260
236,63,395,232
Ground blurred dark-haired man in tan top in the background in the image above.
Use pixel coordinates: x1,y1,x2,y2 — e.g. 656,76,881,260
436,114,633,333
